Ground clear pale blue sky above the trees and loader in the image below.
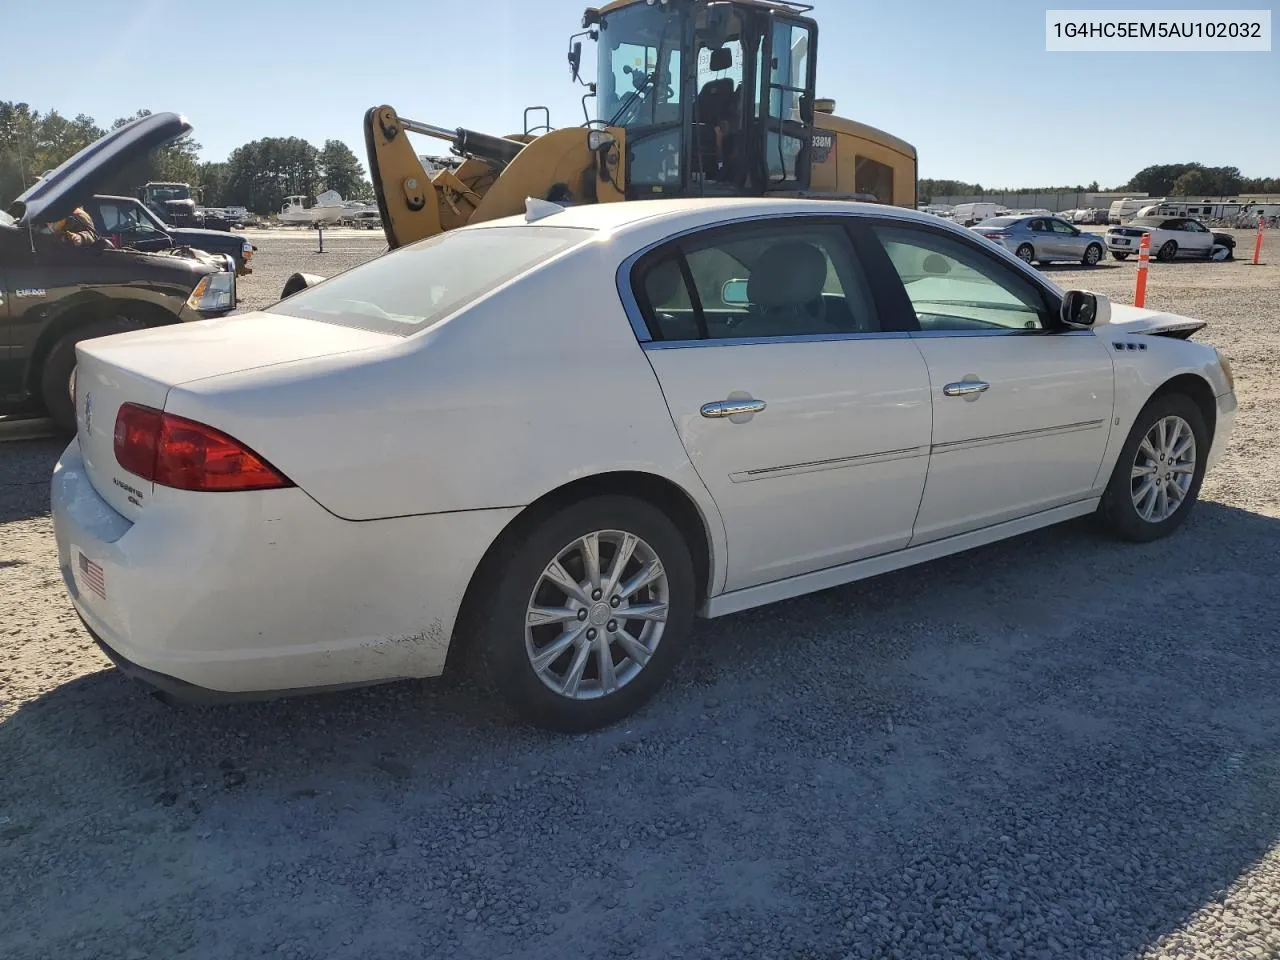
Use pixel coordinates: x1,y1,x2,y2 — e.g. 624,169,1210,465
0,0,1280,187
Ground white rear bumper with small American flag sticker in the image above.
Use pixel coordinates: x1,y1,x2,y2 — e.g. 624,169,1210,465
51,440,516,701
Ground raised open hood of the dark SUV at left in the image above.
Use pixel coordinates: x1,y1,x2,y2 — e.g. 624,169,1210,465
9,113,191,225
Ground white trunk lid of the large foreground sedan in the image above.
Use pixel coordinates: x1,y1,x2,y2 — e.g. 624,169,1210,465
76,314,402,520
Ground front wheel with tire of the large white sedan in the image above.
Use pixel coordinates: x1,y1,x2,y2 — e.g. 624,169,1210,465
1098,393,1211,543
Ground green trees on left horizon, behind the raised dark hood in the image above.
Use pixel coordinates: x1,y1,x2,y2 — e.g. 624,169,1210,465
0,101,374,214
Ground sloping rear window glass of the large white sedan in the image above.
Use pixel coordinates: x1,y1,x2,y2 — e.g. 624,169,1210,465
266,227,595,337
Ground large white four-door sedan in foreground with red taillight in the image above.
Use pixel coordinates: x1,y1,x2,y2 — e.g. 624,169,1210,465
52,200,1235,730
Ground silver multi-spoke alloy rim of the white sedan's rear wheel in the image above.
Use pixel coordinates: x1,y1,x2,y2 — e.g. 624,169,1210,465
525,530,671,700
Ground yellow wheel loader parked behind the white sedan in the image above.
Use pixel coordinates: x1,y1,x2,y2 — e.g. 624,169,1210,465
365,0,916,248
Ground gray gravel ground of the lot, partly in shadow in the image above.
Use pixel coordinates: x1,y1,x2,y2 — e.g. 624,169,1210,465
0,233,1280,960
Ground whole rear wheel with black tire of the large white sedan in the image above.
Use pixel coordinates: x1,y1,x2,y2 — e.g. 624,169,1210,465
470,494,698,732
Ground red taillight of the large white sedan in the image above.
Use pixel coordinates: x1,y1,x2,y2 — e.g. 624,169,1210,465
115,403,293,492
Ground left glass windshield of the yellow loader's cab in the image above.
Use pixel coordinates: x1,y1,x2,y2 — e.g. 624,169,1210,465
596,4,682,127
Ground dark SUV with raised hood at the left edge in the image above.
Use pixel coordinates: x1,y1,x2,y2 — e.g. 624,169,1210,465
0,113,236,433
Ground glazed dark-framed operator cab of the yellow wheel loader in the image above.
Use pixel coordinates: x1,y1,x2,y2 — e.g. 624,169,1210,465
584,0,818,200
